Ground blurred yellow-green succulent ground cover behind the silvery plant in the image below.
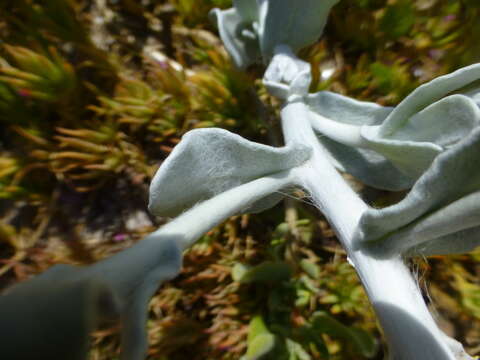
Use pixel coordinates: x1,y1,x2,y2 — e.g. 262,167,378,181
0,0,480,360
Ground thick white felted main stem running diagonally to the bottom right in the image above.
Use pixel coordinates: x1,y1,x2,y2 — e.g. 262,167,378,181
281,97,462,360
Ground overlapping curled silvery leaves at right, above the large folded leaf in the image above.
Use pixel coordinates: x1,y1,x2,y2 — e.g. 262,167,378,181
306,64,480,183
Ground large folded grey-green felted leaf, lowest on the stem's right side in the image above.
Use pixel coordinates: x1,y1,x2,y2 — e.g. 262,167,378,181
356,127,480,254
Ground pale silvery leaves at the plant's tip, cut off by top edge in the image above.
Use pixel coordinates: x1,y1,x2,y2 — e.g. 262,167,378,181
211,0,338,68
